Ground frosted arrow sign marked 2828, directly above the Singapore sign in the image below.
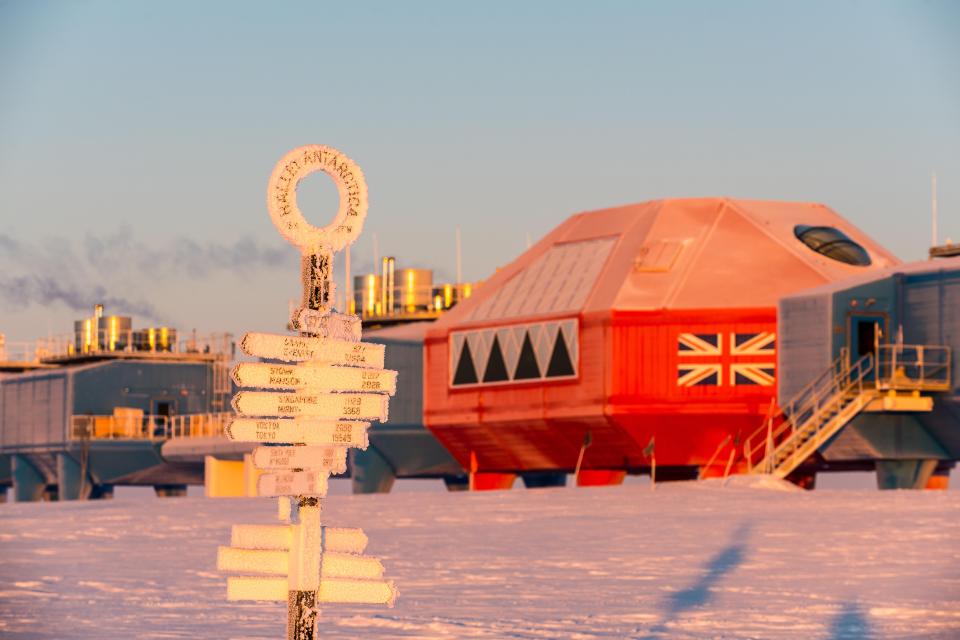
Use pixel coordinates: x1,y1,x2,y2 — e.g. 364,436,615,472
233,362,397,395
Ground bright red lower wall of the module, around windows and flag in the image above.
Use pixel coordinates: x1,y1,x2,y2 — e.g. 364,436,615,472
425,308,776,472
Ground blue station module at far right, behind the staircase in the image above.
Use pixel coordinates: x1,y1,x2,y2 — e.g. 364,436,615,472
778,258,960,488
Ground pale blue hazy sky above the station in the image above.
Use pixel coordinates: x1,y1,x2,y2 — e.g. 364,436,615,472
0,0,960,340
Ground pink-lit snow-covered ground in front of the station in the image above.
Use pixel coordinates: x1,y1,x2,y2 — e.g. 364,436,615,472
0,481,960,640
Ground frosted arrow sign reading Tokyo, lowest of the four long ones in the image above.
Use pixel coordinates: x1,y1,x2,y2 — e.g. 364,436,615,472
224,418,370,449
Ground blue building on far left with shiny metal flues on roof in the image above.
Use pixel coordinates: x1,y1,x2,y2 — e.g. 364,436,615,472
0,305,234,502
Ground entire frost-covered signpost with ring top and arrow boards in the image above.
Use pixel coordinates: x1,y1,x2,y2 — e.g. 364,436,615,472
217,145,397,640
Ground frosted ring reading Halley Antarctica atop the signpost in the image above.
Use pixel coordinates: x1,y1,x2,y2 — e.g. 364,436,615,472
267,144,367,254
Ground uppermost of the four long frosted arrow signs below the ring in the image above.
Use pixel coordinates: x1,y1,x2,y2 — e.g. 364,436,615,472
240,333,385,369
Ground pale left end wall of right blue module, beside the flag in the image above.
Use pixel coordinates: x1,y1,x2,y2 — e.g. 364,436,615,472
777,293,833,404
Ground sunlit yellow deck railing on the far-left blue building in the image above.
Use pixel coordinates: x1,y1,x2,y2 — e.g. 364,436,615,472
70,412,234,441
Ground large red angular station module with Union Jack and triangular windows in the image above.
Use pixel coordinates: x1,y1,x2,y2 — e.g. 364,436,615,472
424,198,899,488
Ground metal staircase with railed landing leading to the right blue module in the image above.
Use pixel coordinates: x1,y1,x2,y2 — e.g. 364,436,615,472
744,344,951,478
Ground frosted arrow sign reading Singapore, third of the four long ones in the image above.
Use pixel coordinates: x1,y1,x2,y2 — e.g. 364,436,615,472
233,391,388,422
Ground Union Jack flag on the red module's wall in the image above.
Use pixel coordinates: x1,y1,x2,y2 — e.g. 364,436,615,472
677,331,777,387
